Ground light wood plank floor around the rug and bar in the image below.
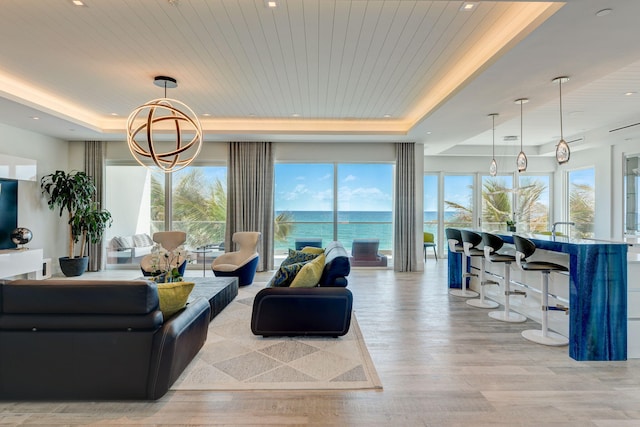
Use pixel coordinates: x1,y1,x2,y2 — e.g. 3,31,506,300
0,259,640,427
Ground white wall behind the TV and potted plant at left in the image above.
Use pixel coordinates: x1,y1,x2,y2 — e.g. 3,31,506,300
0,124,69,271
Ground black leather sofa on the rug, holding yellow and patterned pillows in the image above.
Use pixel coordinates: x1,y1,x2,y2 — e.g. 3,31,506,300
251,242,353,337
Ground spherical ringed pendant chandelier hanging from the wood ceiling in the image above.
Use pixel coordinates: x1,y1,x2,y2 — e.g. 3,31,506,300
127,76,202,173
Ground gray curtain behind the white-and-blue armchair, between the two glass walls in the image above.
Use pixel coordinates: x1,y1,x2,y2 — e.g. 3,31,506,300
225,142,274,271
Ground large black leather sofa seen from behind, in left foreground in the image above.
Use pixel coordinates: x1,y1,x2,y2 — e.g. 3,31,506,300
0,279,210,400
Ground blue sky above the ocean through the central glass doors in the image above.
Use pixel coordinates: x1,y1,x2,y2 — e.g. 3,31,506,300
275,163,393,211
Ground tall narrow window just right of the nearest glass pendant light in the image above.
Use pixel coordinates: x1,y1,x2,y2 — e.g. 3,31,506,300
567,168,596,241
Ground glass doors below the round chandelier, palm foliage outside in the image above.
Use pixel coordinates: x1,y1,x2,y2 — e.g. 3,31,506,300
106,165,227,264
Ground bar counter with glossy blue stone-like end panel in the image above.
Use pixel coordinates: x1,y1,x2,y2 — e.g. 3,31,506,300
448,231,628,361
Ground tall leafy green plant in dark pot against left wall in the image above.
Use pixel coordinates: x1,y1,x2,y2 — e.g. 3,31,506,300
40,170,111,276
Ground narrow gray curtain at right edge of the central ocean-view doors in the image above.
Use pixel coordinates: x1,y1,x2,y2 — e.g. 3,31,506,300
393,142,418,271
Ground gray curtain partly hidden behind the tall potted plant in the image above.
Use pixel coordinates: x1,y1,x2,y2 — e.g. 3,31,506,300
84,141,106,271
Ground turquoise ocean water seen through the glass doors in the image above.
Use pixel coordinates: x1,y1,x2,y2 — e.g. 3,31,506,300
274,211,454,253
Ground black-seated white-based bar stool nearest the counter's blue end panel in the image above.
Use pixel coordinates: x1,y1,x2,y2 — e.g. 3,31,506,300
513,235,569,347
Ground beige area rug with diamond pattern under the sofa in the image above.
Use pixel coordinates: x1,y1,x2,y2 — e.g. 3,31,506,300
171,283,382,390
